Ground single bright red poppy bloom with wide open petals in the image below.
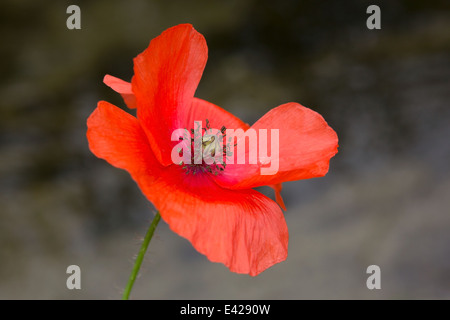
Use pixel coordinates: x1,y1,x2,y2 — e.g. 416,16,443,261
87,24,338,276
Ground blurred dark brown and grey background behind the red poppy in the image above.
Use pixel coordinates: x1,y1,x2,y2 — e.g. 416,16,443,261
0,0,450,299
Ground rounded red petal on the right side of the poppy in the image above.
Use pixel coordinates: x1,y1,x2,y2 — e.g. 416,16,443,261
215,103,338,189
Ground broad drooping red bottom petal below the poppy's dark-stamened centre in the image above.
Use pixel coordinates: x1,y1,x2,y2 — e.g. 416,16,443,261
137,165,289,276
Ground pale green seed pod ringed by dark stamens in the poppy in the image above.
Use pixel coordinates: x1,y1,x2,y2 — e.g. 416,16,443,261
179,119,231,175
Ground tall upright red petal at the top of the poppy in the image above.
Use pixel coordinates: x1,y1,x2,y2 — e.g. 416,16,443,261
132,24,208,165
